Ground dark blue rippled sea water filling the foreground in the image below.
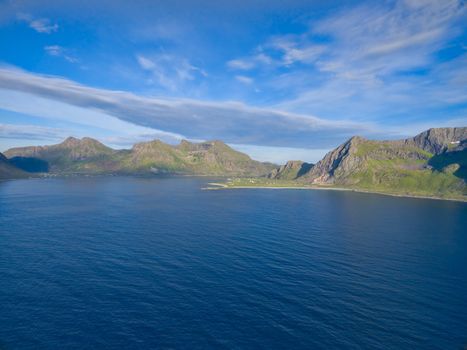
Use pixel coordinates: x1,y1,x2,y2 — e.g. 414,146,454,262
0,177,467,349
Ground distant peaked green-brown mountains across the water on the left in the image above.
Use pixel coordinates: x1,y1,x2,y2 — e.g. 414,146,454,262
5,137,274,176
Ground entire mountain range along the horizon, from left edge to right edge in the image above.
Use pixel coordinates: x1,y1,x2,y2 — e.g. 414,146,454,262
0,127,467,199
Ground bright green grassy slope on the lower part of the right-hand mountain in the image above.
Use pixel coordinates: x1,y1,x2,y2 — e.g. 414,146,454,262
334,141,467,197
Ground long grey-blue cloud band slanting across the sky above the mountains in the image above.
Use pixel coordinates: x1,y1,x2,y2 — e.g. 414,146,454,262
0,68,378,147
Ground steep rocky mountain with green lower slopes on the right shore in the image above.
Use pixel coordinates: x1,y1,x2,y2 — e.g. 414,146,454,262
270,127,467,197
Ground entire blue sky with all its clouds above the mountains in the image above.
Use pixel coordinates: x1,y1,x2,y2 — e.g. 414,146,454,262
0,0,467,163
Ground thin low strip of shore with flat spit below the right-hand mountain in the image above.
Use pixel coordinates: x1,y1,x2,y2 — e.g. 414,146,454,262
207,182,467,203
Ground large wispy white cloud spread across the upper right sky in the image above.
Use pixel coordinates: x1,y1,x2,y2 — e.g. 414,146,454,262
224,0,467,125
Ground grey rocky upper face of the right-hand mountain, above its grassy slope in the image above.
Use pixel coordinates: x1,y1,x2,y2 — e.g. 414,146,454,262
300,128,467,185
